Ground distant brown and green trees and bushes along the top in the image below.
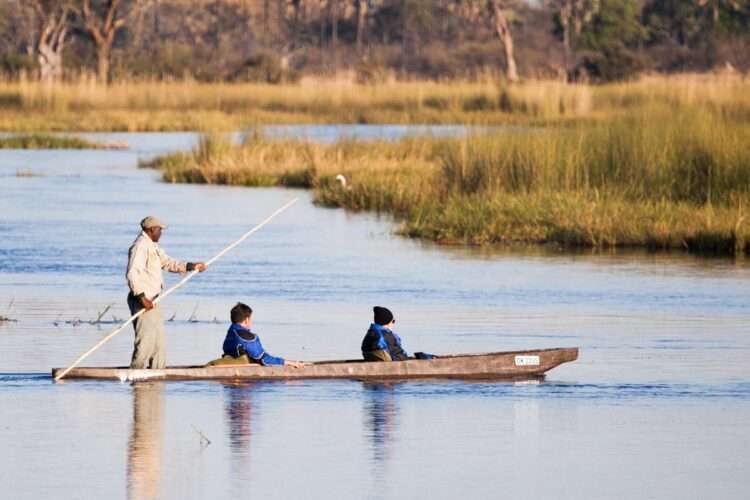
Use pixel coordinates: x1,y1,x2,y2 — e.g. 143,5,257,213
0,0,750,83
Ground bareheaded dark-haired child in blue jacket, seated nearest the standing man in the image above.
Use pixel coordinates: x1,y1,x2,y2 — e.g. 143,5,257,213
223,302,305,368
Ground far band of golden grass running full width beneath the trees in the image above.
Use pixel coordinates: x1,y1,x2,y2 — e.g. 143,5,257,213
0,75,750,132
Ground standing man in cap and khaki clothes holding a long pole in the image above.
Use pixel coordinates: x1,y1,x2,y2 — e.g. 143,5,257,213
127,216,206,368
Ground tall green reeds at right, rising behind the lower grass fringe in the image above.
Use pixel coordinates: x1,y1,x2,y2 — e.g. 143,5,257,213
436,108,750,204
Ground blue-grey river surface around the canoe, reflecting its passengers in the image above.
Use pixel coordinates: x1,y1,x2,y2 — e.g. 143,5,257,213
0,127,750,499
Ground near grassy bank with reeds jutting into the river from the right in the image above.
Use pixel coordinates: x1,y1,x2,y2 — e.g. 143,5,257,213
144,95,750,254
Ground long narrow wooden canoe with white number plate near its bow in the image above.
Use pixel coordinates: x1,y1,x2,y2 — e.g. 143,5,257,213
52,347,578,382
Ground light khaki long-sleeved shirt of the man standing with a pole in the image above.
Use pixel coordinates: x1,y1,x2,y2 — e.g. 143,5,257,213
126,232,187,300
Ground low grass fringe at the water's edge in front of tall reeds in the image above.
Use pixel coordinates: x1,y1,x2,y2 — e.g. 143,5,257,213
402,193,750,254
